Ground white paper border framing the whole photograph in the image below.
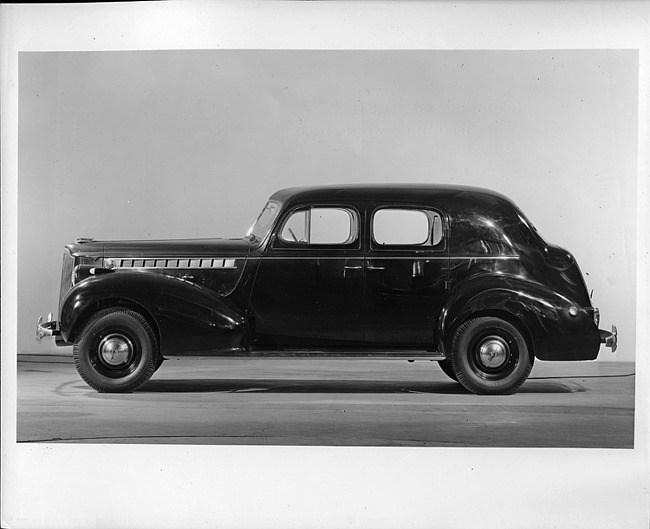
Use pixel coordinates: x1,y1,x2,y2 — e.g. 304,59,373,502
0,1,650,529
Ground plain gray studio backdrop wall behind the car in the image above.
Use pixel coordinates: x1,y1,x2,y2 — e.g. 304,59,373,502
17,50,638,361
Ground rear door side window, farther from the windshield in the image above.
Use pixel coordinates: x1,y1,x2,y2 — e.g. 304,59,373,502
372,208,442,246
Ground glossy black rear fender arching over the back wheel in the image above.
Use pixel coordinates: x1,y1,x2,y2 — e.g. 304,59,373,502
437,277,600,360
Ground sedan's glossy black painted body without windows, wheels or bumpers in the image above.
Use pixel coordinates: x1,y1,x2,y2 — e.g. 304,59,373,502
52,185,601,360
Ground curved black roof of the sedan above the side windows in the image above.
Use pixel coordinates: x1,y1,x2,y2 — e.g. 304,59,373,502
271,184,515,210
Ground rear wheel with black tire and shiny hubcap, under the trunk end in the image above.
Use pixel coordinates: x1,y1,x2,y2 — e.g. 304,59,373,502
449,317,534,395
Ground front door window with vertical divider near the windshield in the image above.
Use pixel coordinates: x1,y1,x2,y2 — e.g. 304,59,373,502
280,207,359,245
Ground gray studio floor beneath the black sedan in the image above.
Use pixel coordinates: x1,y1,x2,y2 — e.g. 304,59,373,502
17,355,635,448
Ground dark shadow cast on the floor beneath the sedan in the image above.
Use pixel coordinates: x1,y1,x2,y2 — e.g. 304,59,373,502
138,378,587,395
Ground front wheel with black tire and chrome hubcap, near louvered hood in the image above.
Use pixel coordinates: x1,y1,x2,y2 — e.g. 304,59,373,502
73,309,162,393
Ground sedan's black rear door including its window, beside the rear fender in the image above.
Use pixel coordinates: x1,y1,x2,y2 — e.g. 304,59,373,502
364,204,449,350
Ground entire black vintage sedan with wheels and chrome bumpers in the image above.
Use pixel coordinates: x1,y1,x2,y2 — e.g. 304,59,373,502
37,185,617,394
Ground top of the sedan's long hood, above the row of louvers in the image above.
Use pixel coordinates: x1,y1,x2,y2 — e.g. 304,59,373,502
66,239,250,258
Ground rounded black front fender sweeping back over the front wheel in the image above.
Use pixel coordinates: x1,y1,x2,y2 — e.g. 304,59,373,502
59,271,249,355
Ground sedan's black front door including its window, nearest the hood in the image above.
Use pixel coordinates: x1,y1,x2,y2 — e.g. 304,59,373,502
251,203,364,346
